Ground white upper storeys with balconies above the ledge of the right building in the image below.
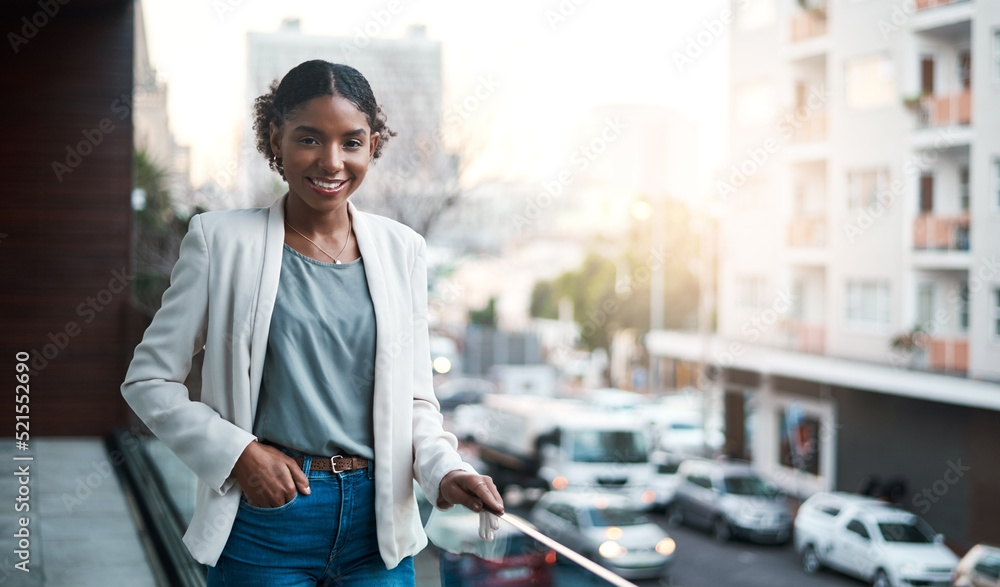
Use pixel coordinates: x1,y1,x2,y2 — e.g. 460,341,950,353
717,0,1000,380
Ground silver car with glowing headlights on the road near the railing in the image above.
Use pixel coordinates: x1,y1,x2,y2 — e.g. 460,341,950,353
530,491,676,579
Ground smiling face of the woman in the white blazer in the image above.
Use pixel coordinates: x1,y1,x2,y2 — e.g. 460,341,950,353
271,96,378,212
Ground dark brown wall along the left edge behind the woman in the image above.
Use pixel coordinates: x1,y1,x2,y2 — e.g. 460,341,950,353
0,0,135,436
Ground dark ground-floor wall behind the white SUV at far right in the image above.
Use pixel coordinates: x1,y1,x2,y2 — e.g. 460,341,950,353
834,389,1000,552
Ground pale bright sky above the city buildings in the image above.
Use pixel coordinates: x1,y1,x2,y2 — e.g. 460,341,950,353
142,0,729,198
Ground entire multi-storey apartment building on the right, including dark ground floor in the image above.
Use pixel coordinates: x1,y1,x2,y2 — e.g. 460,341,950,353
647,0,1000,545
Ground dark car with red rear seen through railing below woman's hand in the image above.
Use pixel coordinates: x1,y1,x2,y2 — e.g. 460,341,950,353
424,507,556,587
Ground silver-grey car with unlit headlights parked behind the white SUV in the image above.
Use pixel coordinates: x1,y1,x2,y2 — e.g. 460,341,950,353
668,459,792,544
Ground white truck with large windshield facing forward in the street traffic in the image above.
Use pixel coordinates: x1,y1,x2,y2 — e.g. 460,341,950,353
477,394,655,506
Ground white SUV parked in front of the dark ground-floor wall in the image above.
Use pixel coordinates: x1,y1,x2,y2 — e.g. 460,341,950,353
795,492,958,587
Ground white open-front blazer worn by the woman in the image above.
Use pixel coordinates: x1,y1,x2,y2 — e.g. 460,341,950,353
122,197,473,568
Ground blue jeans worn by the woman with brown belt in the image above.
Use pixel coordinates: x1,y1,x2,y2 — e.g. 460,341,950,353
208,455,414,587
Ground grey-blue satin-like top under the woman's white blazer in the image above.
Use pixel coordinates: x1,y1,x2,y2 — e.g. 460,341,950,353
254,244,375,459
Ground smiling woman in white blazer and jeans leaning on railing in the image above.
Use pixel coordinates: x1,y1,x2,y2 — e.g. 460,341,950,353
122,60,503,587
